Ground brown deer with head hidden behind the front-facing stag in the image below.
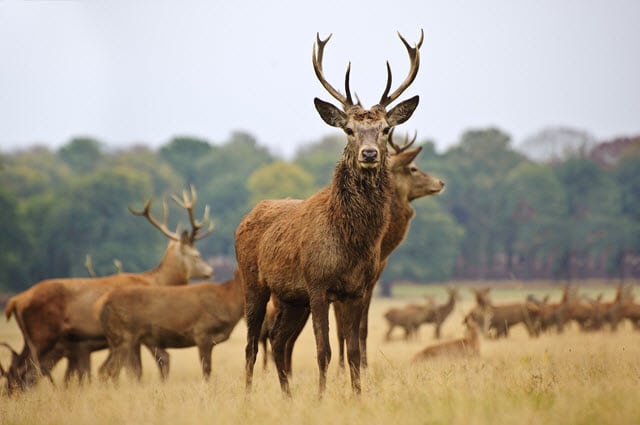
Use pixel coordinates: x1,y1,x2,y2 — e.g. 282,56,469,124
94,271,244,380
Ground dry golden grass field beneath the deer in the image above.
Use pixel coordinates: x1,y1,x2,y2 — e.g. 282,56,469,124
0,287,640,425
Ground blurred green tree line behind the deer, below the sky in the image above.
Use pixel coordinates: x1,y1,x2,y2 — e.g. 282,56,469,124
0,128,640,292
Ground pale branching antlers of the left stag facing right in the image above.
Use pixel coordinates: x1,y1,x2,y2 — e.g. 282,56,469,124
129,185,213,243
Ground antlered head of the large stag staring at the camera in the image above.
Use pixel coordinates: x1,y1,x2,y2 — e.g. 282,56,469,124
312,32,424,170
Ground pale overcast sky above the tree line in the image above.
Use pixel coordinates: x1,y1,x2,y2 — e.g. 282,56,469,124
0,0,640,156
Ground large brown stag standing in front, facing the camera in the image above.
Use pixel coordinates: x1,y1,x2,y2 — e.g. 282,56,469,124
235,31,422,395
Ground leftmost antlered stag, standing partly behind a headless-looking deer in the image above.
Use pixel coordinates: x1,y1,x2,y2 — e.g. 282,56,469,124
5,187,213,388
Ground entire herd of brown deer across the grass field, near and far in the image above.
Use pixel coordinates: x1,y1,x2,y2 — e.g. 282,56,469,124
0,32,640,396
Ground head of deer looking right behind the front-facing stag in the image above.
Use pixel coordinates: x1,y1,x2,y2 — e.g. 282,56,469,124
389,131,444,201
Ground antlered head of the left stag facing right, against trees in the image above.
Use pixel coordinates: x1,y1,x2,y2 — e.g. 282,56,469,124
129,186,213,279
